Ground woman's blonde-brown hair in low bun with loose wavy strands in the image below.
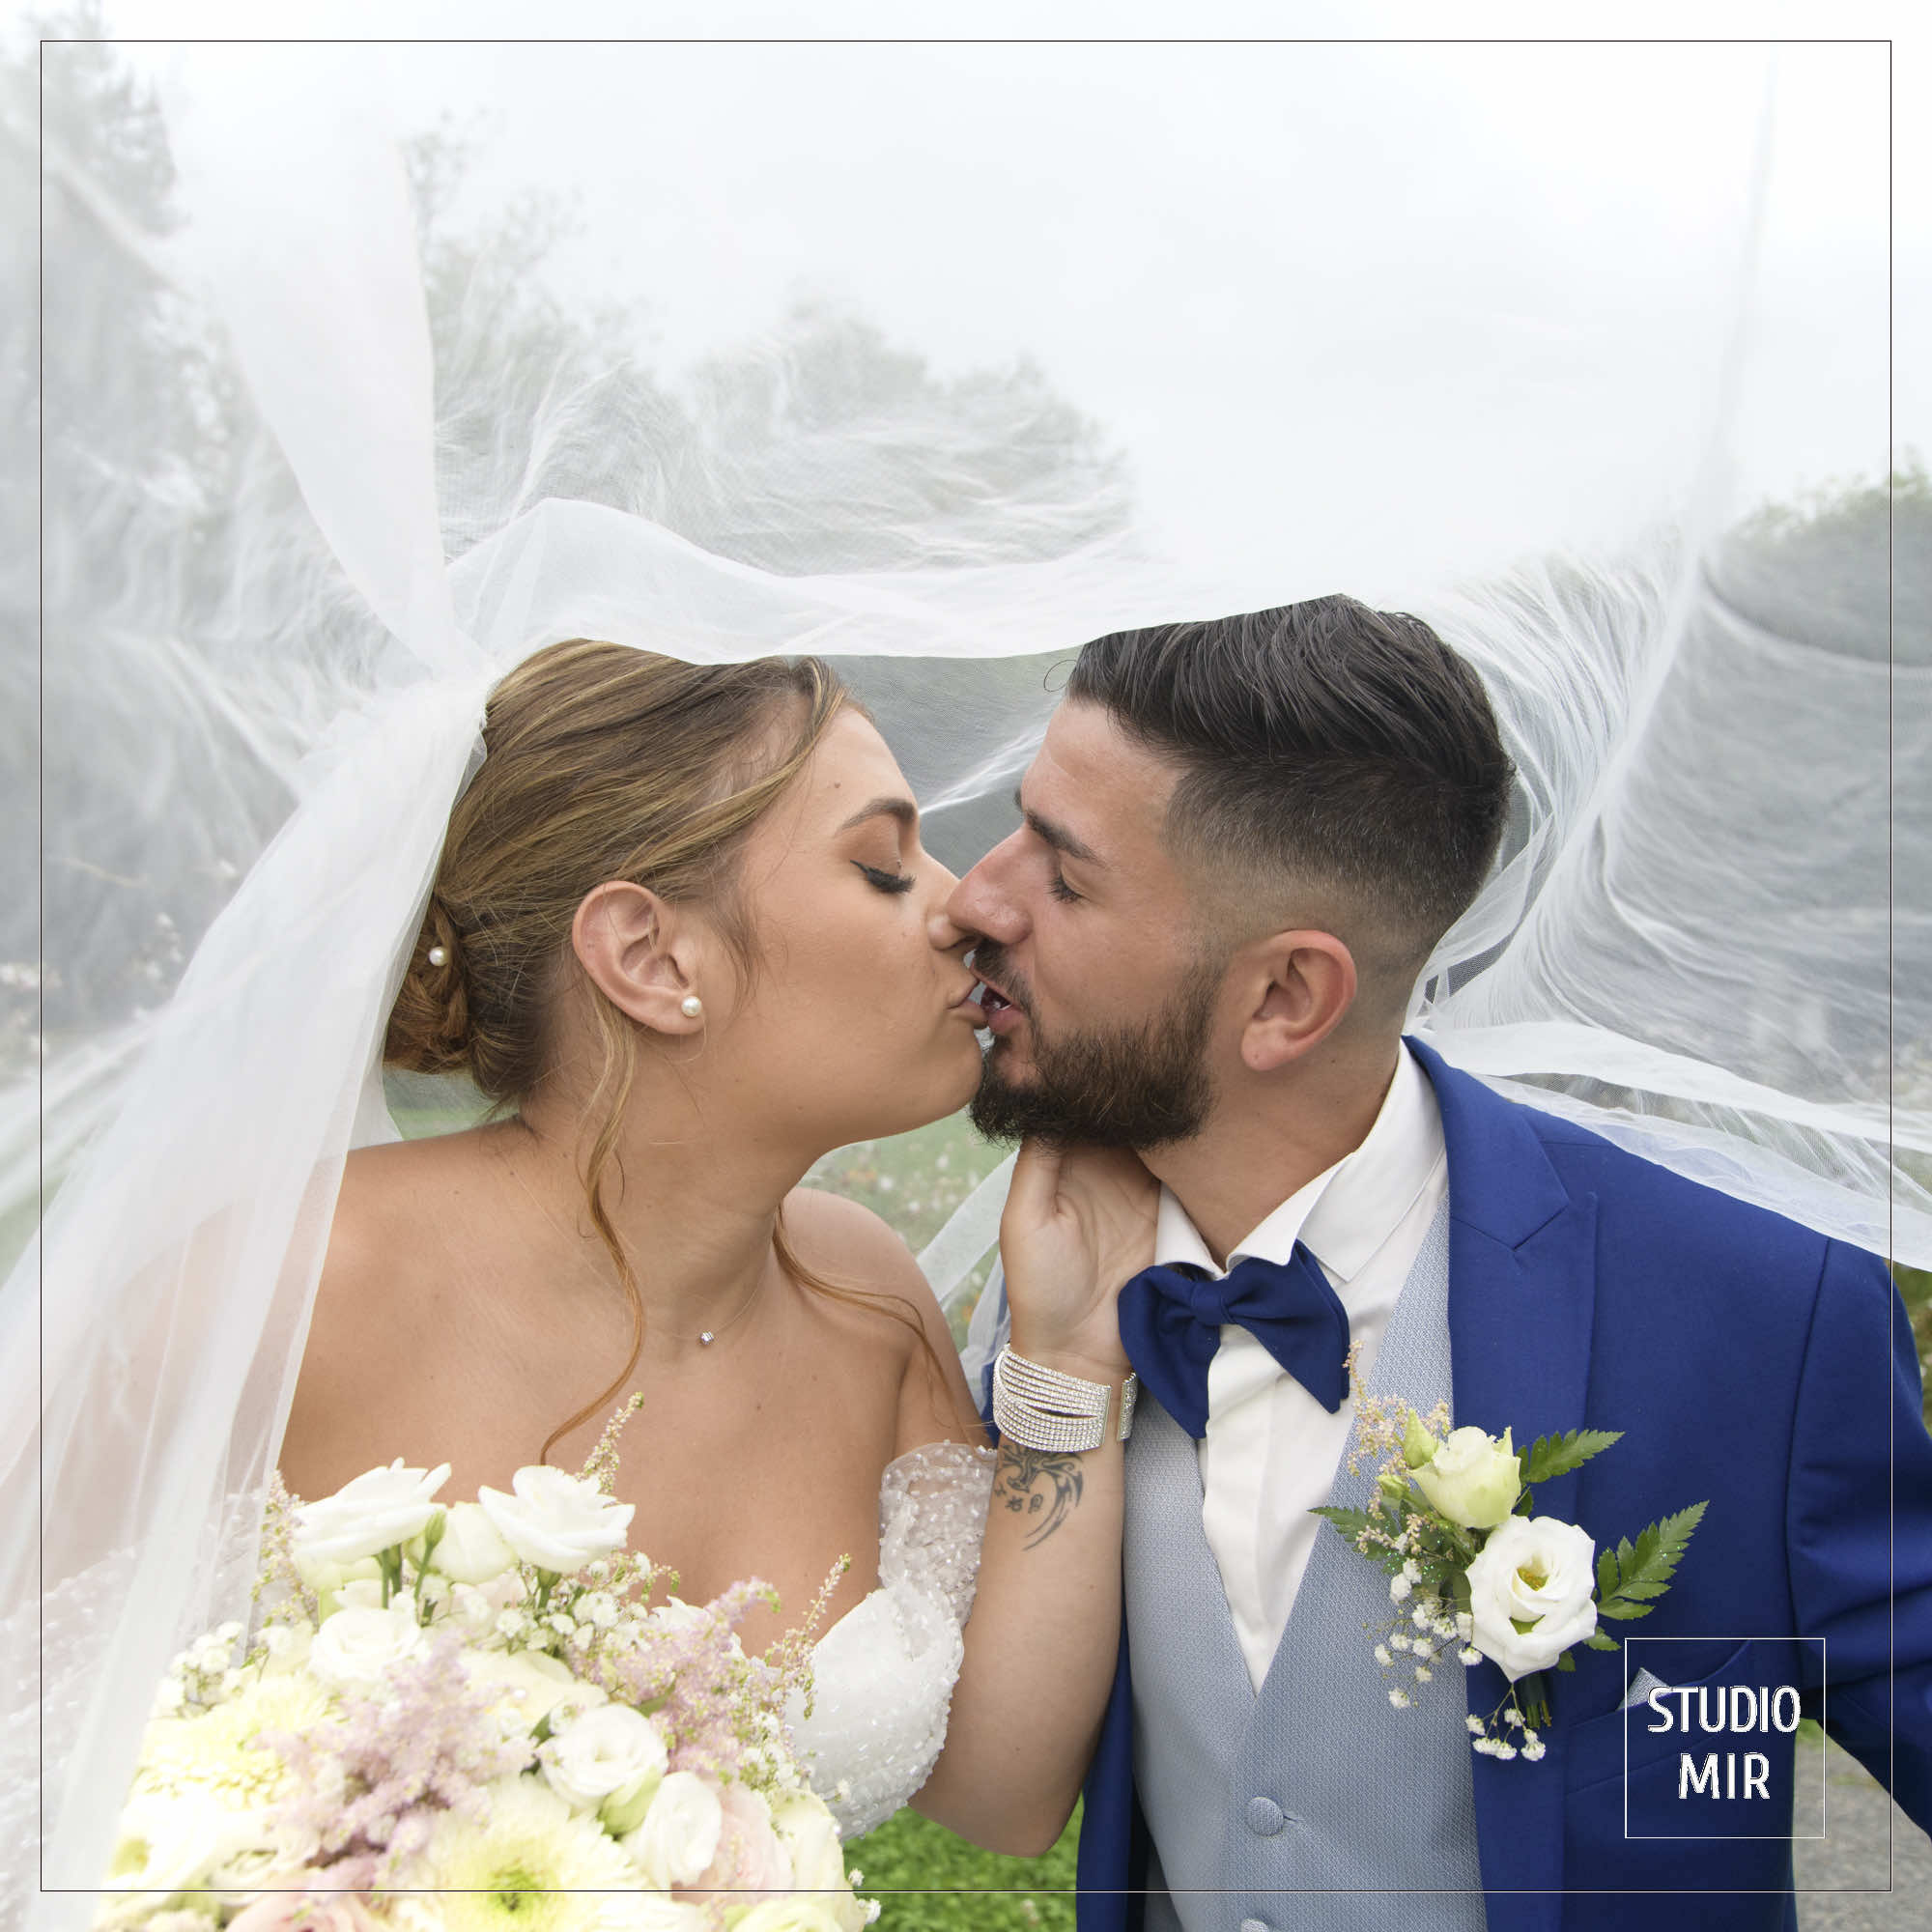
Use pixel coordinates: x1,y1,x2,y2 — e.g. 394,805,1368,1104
383,638,885,1457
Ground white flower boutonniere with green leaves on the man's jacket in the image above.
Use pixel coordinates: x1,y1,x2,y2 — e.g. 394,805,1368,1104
1316,1387,1704,1764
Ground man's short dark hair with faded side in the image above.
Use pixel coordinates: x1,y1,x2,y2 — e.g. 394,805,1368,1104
1066,597,1513,968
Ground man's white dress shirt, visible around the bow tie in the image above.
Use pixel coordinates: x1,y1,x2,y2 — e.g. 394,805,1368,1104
1153,1047,1449,1690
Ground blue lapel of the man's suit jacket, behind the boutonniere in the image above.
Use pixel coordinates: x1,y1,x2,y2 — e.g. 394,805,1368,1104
1408,1039,1596,1932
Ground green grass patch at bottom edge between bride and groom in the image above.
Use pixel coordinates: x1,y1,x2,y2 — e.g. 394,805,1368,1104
846,1806,1080,1932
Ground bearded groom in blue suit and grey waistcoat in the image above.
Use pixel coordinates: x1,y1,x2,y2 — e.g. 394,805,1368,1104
949,597,1932,1932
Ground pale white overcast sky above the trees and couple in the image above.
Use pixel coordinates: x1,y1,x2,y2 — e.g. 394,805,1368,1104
42,0,1932,593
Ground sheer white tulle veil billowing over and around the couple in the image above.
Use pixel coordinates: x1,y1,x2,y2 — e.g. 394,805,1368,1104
0,22,1932,1924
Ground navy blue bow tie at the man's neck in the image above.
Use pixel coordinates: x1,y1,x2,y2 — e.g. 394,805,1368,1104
1119,1242,1349,1441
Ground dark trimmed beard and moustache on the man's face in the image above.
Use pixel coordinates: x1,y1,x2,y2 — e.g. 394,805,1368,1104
968,939,1221,1151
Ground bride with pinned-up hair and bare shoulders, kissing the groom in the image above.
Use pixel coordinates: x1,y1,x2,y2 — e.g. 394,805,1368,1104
280,641,1153,1853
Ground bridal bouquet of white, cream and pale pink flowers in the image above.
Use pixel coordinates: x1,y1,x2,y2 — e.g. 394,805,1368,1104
97,1408,879,1932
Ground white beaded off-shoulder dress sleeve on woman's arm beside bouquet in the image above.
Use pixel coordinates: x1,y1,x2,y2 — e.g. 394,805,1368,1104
788,1443,993,1837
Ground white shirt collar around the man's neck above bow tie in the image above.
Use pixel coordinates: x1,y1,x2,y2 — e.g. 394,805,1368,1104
1153,1045,1443,1281
